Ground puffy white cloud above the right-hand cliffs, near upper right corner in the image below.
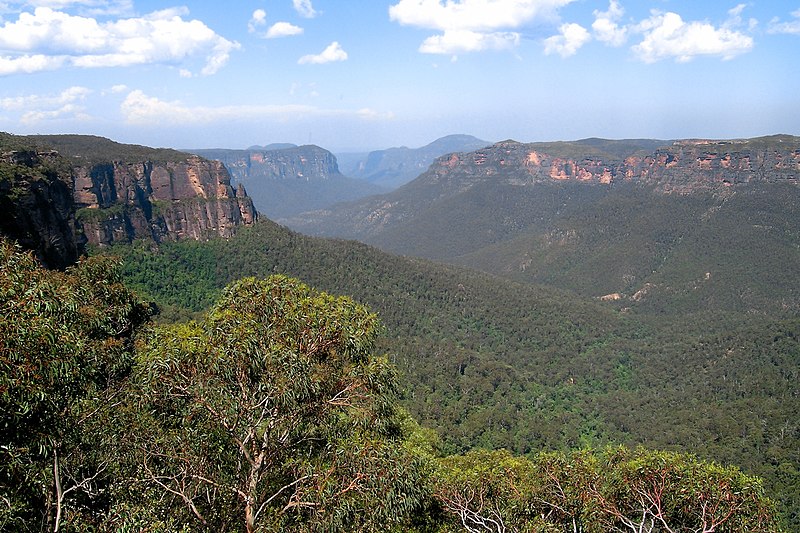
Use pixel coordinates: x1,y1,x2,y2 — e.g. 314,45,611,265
631,12,753,63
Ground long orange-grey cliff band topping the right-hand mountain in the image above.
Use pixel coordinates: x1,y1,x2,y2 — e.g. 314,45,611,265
428,136,800,193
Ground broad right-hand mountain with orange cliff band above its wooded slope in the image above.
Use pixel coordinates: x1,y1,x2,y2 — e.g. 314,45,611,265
290,136,800,312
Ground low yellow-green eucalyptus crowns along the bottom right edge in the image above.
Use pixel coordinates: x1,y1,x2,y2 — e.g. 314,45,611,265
434,447,779,533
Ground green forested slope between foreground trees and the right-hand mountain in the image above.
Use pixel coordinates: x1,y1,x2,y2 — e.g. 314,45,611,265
101,222,800,523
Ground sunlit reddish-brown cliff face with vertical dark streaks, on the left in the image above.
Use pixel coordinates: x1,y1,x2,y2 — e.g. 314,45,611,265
74,156,258,245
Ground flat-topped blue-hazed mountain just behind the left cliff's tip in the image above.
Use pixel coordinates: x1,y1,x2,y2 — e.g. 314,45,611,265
193,145,386,220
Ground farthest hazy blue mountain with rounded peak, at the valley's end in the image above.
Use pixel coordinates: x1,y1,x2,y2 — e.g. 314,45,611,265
337,135,491,189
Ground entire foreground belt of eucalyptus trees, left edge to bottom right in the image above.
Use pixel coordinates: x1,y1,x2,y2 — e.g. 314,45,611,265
0,239,779,532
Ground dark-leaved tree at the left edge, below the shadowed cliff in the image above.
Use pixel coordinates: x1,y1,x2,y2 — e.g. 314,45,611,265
0,240,149,531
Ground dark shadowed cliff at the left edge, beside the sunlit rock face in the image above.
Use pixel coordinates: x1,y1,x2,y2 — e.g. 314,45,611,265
0,150,85,268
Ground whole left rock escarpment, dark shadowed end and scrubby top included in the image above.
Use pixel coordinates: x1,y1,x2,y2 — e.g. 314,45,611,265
0,133,258,268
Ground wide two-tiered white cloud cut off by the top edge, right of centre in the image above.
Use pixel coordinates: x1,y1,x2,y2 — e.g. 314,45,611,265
389,0,574,54
